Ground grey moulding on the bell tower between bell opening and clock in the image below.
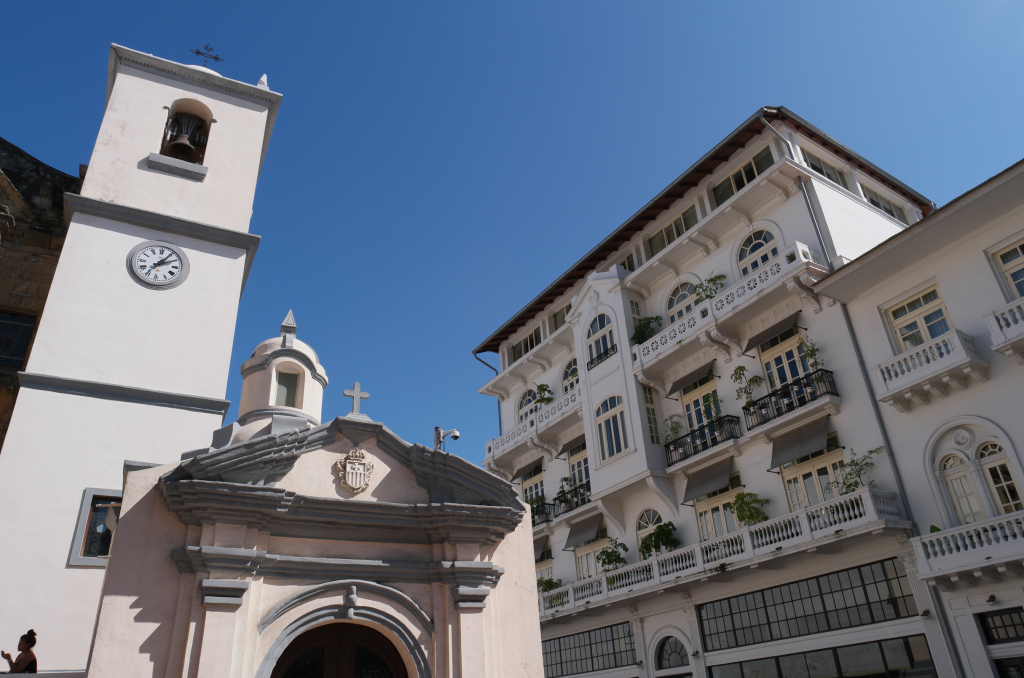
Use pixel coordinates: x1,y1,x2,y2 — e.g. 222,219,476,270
65,193,260,295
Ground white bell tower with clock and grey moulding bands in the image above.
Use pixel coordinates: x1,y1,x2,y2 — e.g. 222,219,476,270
0,45,281,671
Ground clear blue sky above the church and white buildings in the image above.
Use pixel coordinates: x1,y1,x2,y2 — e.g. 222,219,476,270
0,0,1024,462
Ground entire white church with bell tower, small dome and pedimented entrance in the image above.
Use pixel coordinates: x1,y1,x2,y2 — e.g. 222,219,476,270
0,45,542,678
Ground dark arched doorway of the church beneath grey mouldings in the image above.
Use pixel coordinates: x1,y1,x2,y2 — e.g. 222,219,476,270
271,624,409,678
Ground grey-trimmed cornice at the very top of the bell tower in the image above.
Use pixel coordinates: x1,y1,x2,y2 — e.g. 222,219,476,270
103,44,282,174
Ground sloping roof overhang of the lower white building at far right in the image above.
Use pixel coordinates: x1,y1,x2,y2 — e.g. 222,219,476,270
814,160,1024,303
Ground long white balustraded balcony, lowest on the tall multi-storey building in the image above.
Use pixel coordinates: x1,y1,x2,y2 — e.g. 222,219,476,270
539,488,910,619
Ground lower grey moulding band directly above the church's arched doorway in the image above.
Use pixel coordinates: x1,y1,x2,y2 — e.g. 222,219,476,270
171,546,505,588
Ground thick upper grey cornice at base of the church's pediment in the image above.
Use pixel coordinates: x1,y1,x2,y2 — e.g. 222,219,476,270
160,480,523,545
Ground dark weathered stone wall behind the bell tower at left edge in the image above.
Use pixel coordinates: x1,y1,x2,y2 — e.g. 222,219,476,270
0,138,82,444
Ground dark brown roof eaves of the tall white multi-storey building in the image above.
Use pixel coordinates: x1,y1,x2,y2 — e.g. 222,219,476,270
473,107,934,353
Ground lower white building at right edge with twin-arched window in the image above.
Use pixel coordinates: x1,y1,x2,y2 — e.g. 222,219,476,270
814,155,1024,677
